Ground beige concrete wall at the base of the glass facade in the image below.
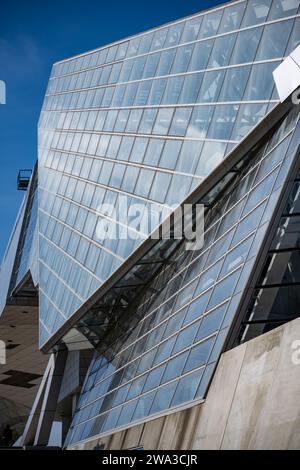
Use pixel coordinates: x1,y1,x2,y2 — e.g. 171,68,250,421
72,318,300,449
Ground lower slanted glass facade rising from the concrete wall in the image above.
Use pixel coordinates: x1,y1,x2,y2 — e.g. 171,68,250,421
67,107,300,444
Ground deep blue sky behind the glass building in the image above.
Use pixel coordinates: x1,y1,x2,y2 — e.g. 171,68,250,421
0,0,223,259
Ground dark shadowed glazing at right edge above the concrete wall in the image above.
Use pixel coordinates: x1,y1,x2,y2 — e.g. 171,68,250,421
237,168,300,343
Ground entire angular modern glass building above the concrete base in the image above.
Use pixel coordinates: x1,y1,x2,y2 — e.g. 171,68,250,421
0,0,300,447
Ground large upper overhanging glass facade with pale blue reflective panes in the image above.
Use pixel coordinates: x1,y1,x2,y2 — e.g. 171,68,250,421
39,0,300,346
